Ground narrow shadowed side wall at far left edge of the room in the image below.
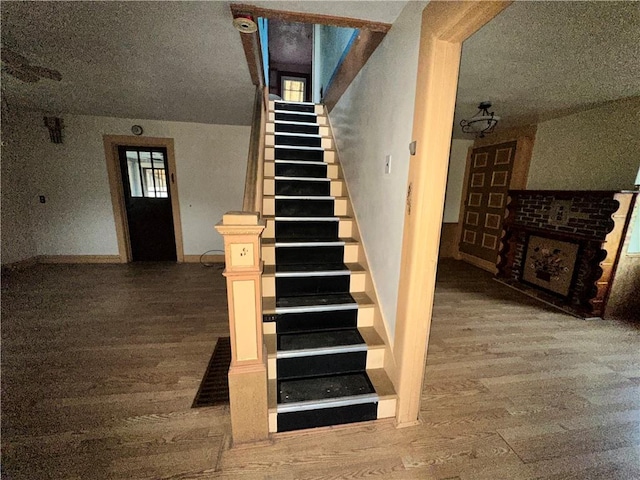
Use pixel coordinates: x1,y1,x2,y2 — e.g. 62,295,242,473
0,112,37,265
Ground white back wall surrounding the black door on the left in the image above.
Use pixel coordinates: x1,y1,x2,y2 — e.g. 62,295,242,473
3,109,250,262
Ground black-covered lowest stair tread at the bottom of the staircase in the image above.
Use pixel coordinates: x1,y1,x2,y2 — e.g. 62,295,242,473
278,372,375,404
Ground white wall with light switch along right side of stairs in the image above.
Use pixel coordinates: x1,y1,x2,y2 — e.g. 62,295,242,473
330,2,426,337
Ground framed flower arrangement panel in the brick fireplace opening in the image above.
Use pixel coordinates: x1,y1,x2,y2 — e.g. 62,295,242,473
522,235,579,297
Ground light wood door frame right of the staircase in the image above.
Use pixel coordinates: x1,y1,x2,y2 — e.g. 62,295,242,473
392,1,512,427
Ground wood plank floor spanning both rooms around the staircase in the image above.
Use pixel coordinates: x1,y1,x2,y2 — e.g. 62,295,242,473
2,261,640,480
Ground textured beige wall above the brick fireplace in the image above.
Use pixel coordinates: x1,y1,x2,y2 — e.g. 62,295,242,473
527,97,640,190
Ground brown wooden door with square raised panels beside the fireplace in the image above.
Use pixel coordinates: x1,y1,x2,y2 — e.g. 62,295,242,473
460,142,516,263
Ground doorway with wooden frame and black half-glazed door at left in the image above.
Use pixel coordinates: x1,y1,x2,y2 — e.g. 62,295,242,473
103,135,184,263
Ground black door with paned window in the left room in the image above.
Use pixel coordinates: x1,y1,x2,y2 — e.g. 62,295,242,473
118,147,176,261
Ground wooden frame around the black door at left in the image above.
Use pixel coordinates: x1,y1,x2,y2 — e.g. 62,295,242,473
102,135,184,263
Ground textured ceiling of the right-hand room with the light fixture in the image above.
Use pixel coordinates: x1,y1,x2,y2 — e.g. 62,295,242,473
454,1,640,138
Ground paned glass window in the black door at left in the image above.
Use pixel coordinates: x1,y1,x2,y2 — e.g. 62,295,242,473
126,149,169,198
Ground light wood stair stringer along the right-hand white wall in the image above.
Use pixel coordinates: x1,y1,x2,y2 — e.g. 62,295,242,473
323,105,399,408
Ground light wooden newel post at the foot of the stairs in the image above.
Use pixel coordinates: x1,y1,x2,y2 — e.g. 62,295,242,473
215,212,269,444
